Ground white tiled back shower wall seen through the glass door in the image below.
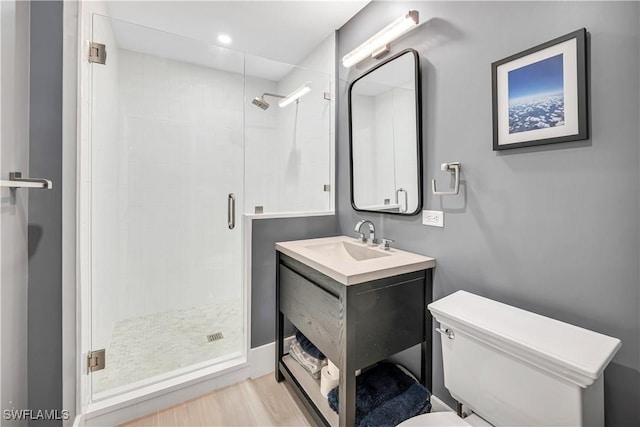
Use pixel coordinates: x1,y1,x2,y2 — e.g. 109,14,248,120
118,50,244,317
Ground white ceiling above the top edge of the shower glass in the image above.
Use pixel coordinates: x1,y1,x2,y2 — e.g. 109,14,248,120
108,0,370,64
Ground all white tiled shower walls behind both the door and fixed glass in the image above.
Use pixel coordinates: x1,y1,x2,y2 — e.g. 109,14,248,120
91,29,333,354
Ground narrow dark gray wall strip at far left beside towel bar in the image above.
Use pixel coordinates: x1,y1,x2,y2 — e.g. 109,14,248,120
28,1,63,425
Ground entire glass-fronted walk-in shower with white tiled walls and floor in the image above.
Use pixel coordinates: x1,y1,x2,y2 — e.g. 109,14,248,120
79,14,331,402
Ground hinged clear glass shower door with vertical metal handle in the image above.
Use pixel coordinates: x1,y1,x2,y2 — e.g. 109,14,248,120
90,15,245,401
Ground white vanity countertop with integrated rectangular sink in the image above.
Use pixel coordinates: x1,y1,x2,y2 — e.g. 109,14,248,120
276,236,436,285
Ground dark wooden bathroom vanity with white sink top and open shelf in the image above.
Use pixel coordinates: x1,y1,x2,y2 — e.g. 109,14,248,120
276,236,435,427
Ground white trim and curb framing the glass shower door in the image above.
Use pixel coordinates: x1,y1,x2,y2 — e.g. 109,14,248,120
74,2,251,425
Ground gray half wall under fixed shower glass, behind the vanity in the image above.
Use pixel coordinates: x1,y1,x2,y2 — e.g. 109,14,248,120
251,215,338,348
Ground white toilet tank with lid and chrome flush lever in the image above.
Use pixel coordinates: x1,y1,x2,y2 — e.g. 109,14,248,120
429,291,621,426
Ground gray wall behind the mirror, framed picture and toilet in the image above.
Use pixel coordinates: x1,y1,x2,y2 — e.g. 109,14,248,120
337,2,640,426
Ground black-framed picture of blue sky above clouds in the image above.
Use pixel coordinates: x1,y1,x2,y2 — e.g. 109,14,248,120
491,28,589,150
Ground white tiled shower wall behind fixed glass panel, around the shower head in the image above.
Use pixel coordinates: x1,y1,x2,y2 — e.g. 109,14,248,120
245,35,335,213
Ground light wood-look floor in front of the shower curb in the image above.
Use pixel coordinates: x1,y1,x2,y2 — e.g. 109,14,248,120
120,374,316,427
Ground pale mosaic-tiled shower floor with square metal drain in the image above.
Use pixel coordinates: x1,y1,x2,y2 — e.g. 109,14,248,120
93,299,243,394
